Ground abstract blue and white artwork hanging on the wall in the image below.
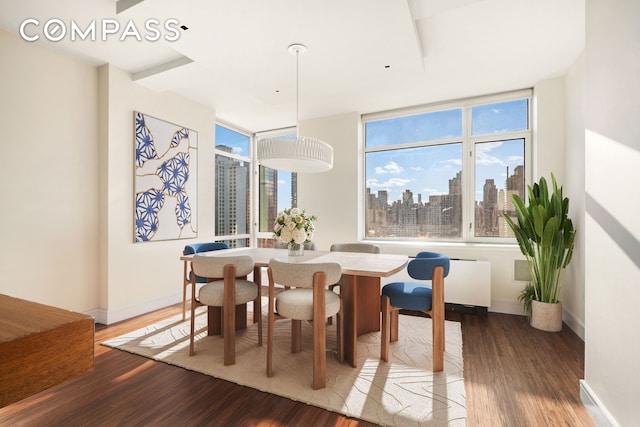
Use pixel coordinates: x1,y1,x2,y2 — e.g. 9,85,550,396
134,112,198,242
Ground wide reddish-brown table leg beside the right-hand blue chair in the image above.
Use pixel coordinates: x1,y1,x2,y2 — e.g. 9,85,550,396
340,274,380,368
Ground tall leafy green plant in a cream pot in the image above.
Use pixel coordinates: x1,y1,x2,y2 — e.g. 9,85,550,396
503,173,575,332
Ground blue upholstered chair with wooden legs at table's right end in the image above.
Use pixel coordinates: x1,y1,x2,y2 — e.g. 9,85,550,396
380,252,449,372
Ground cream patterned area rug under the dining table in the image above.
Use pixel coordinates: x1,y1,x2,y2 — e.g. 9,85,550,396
102,307,466,426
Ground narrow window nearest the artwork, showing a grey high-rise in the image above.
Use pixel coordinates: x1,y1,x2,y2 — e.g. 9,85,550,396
215,125,251,247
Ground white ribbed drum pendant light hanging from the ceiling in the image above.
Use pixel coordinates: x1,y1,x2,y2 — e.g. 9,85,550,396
257,43,333,173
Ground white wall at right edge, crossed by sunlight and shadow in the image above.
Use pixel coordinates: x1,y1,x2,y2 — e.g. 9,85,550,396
582,0,640,426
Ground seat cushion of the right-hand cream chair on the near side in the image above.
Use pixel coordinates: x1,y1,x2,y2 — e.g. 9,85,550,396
276,288,340,321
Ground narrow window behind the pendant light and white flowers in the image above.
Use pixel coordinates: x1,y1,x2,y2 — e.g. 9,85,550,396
256,128,297,247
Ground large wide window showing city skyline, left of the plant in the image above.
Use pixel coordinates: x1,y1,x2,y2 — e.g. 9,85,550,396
363,90,531,241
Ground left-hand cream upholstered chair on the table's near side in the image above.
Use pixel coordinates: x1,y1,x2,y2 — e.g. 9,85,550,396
189,254,262,365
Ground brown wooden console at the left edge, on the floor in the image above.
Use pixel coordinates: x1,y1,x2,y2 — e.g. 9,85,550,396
0,295,95,407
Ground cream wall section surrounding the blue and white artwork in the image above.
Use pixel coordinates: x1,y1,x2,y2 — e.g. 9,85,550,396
99,65,215,323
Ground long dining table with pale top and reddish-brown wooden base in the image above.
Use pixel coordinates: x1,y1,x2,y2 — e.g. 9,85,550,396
180,248,409,368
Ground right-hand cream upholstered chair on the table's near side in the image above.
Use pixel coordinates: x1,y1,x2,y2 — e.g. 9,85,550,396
267,259,343,390
